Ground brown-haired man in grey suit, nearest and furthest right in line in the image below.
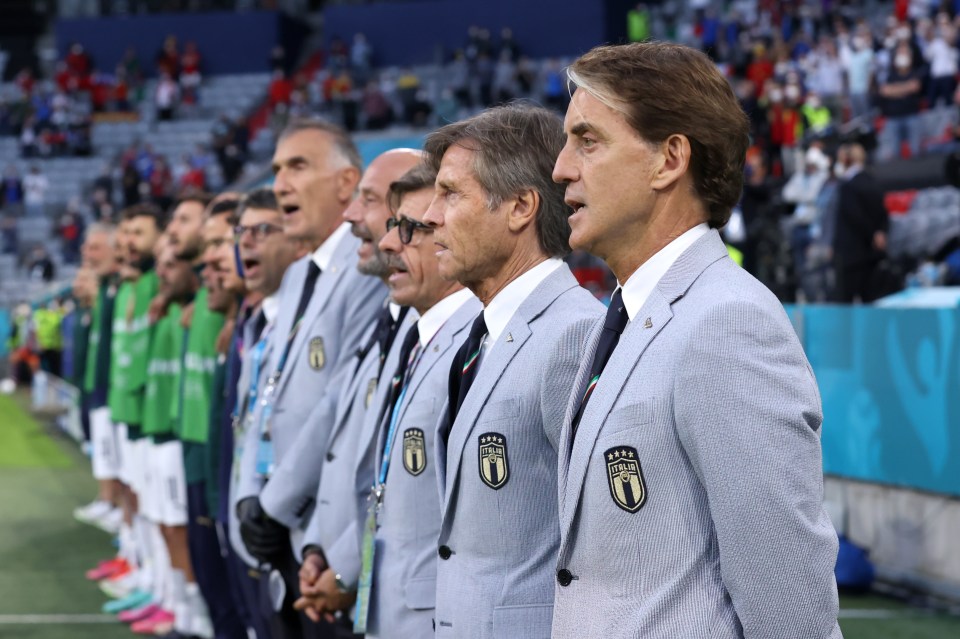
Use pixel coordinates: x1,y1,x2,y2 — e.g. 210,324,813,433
553,43,841,639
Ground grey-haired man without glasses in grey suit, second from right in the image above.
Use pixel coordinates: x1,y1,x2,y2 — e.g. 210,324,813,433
424,105,603,639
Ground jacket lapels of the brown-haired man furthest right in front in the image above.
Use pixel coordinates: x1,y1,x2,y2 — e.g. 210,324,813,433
560,230,729,538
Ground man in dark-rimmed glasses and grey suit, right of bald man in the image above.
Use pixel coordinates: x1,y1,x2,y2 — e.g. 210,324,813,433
354,165,482,637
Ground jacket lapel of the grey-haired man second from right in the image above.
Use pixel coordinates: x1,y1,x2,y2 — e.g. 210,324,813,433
443,264,579,509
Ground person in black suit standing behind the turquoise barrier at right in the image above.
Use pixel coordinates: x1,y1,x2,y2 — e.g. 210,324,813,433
833,144,890,303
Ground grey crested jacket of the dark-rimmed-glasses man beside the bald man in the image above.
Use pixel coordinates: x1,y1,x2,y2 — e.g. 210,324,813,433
367,297,483,639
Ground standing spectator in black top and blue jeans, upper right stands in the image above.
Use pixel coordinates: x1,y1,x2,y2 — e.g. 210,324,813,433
879,41,923,160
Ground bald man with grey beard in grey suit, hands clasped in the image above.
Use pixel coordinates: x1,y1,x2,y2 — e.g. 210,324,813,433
286,149,422,621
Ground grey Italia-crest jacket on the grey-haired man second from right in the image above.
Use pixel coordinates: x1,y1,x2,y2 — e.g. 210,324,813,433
436,265,603,639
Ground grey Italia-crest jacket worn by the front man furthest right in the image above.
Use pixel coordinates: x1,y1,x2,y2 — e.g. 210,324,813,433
553,231,841,639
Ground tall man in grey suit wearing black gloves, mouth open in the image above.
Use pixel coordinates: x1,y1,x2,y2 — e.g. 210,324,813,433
237,120,386,637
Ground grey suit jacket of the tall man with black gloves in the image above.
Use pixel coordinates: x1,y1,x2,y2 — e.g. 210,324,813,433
239,230,386,549
